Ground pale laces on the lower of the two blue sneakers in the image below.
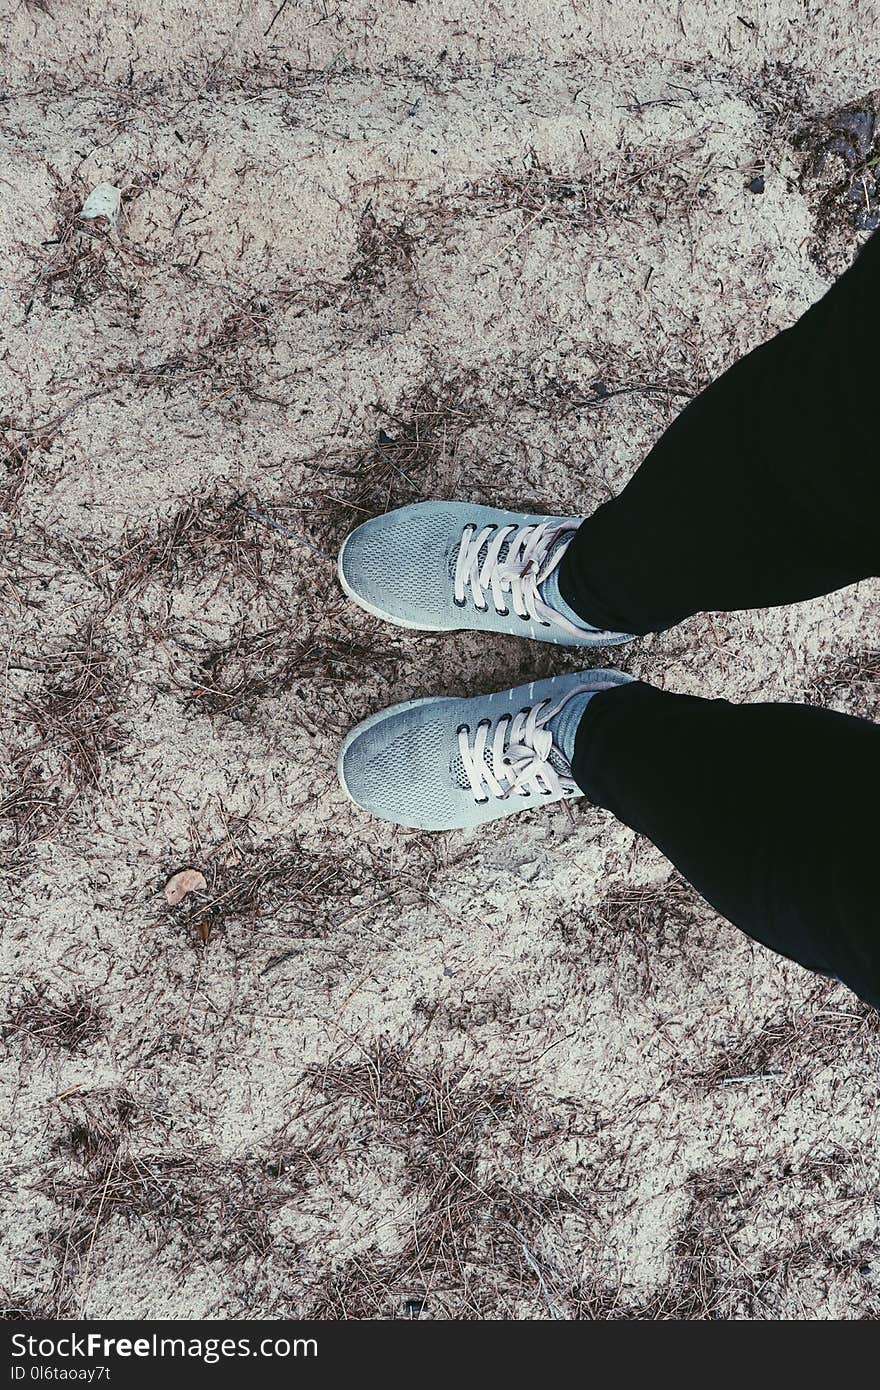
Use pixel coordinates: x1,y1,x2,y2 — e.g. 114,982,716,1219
459,685,594,801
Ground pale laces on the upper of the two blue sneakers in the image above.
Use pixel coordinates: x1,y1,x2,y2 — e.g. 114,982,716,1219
453,521,592,637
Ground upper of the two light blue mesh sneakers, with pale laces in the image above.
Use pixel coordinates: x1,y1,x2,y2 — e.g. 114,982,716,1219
338,502,631,646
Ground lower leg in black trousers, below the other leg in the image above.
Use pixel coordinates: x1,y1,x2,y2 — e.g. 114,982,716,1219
571,681,880,1006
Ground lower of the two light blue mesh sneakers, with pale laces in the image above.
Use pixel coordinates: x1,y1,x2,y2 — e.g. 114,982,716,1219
338,671,633,830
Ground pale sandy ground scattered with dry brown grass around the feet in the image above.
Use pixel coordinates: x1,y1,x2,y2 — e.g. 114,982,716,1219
0,0,880,1319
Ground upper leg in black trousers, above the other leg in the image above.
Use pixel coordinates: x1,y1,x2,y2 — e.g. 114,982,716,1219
559,234,880,634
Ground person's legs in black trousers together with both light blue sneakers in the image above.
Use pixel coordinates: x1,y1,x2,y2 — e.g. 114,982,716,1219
339,239,880,1006
